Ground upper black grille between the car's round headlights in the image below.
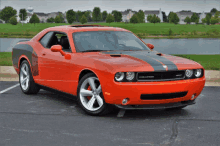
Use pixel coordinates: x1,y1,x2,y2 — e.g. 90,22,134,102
137,70,185,81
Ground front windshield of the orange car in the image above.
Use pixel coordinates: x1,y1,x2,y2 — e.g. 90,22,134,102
73,31,150,52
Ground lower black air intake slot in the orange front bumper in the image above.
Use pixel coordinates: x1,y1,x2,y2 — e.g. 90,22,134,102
141,91,188,100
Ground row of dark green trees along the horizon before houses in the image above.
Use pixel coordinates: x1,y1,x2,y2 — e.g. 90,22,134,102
0,6,220,25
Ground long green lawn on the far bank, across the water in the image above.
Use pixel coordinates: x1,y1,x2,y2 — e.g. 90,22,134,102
0,22,220,38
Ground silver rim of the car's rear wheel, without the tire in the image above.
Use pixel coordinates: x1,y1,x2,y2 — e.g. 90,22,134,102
20,63,30,90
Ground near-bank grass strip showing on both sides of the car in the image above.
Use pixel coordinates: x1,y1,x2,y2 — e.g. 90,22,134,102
0,52,220,70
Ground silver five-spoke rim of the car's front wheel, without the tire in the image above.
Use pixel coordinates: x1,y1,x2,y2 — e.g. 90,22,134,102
80,77,104,111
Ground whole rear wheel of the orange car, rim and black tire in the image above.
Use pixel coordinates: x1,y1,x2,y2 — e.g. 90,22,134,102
19,60,40,94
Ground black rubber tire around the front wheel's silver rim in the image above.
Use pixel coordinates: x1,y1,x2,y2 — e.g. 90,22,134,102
77,73,114,116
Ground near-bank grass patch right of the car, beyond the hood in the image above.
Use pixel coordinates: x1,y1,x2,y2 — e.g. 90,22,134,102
175,54,220,70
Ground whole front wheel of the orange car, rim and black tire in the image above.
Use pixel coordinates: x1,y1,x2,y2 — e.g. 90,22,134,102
77,73,111,115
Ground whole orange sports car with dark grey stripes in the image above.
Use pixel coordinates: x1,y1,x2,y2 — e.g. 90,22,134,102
12,25,205,115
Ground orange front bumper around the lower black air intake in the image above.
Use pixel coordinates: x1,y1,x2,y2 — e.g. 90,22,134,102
102,76,205,106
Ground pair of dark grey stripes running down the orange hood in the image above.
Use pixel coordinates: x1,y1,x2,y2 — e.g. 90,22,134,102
102,51,178,71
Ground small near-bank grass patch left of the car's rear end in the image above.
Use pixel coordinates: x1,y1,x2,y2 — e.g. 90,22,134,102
0,52,12,66
